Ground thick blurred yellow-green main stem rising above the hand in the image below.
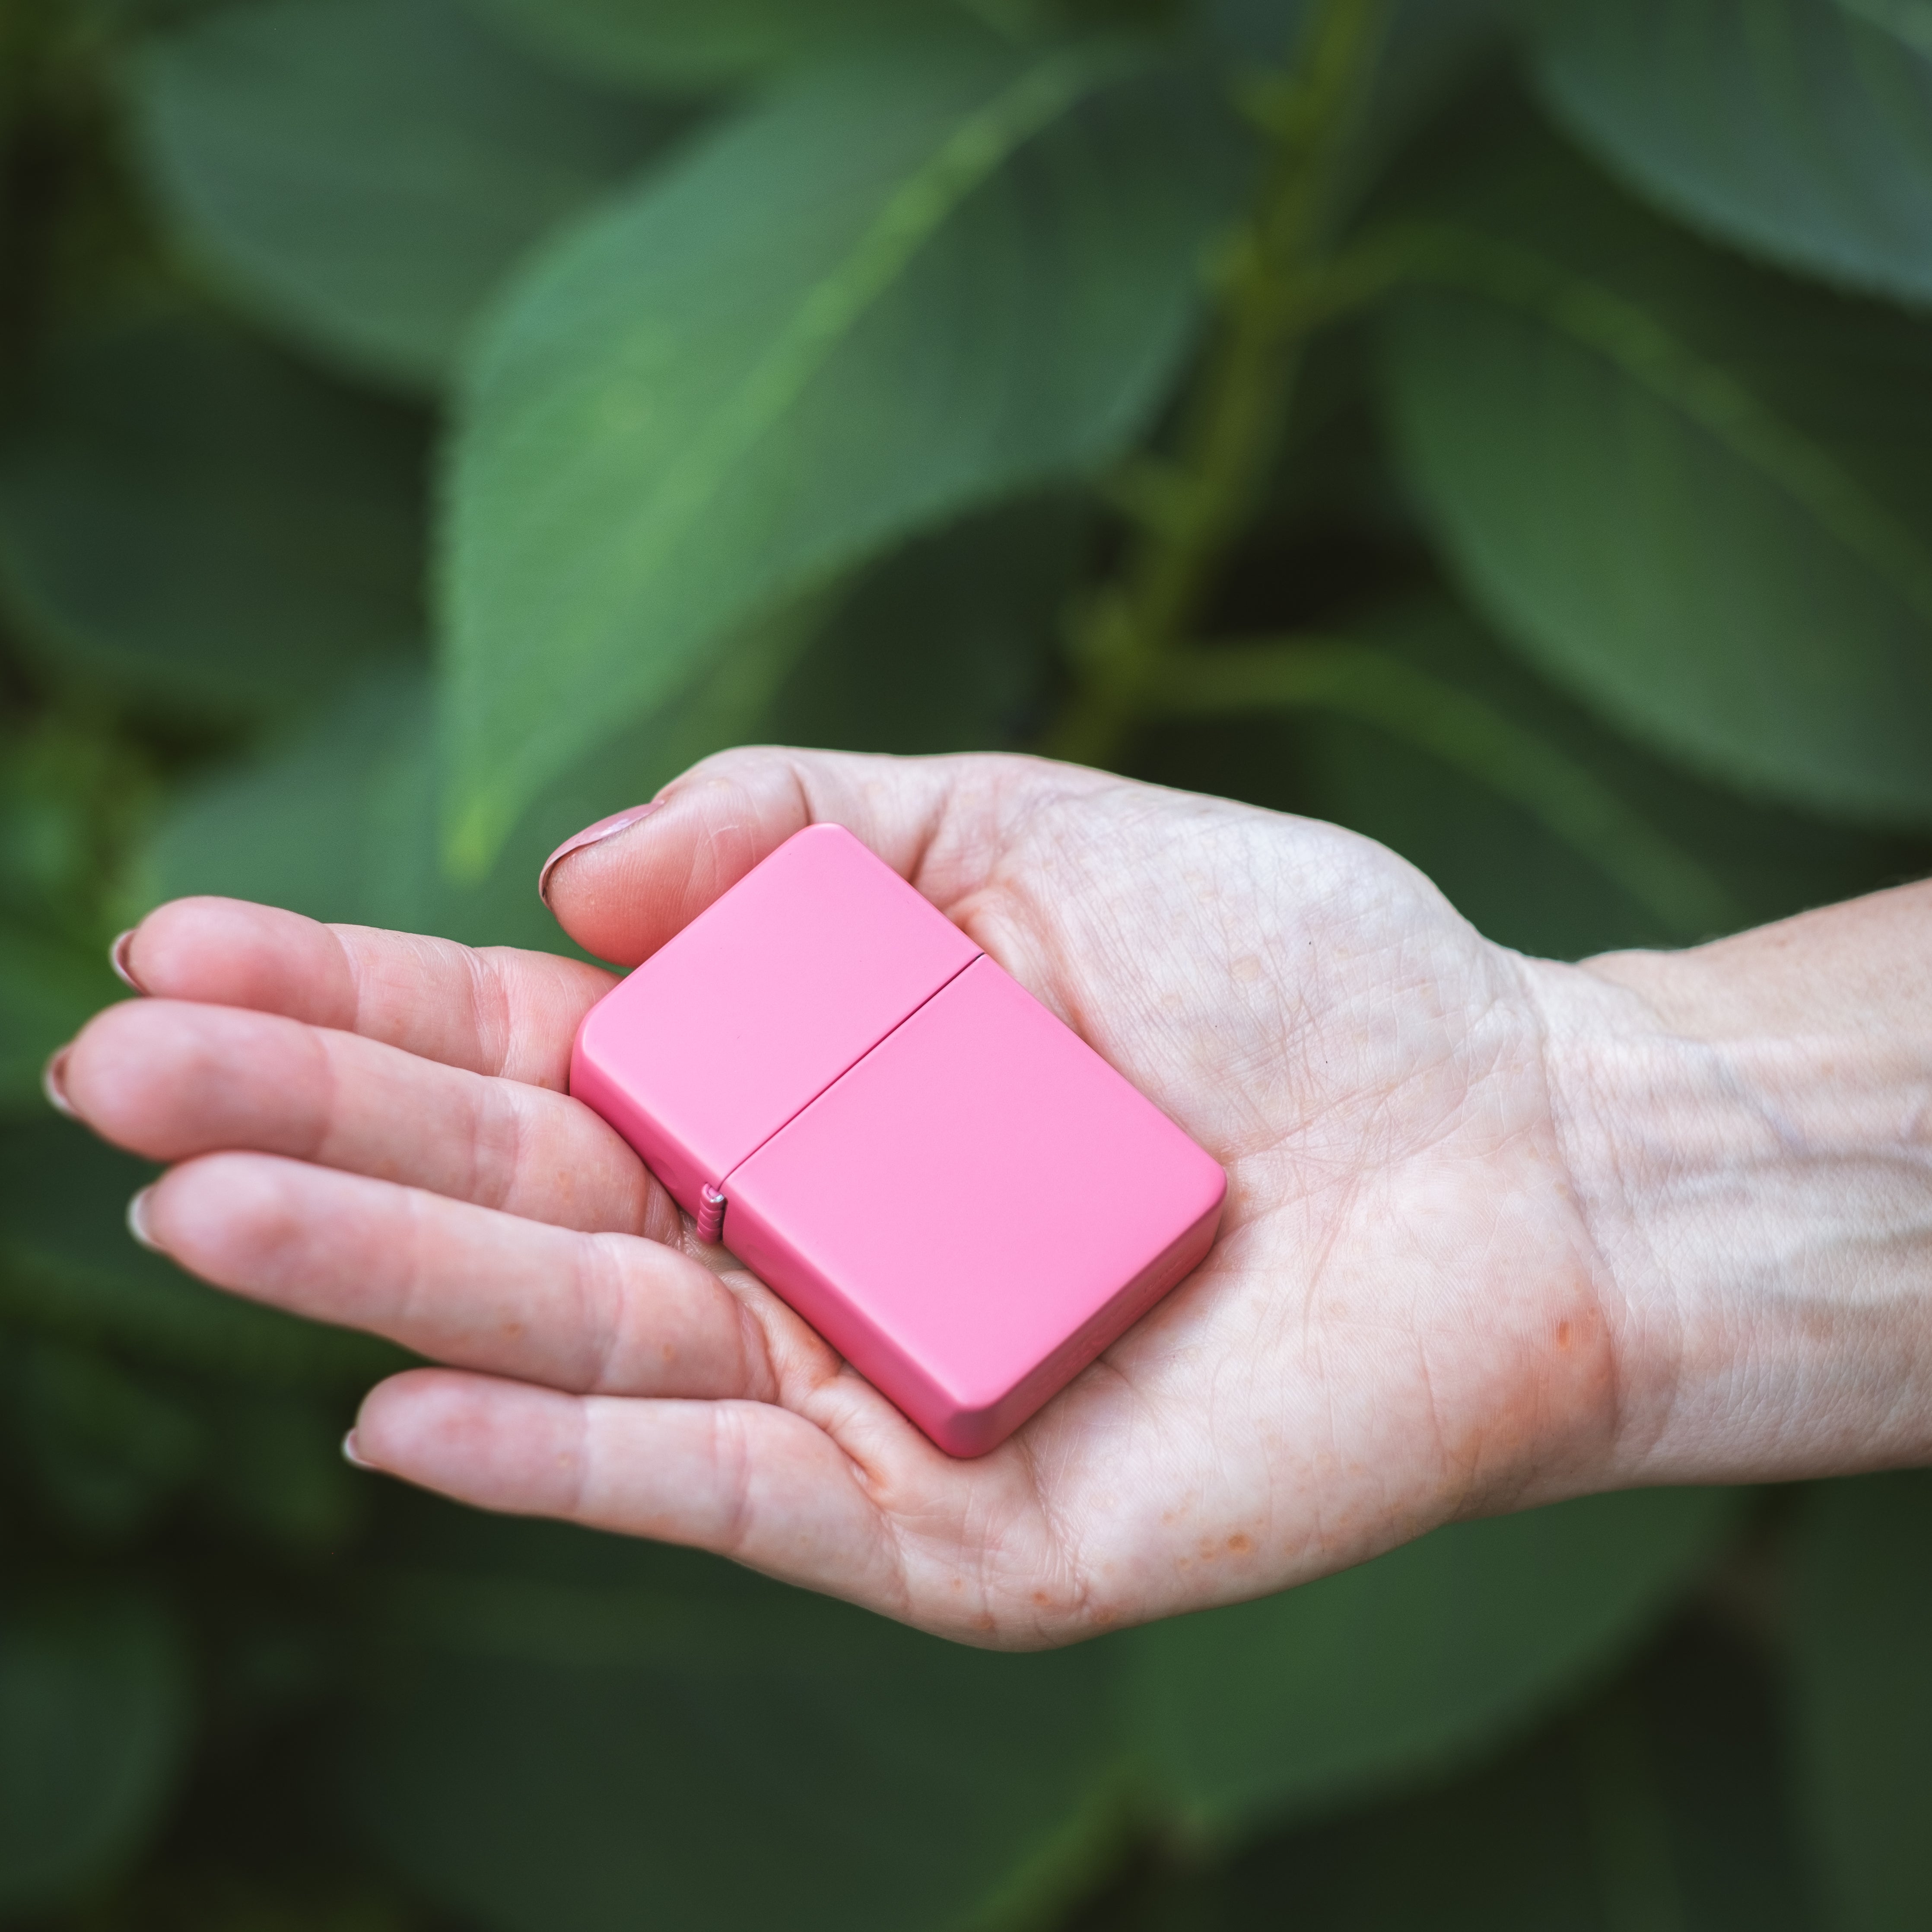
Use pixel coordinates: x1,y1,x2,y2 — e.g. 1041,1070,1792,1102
1045,0,1387,763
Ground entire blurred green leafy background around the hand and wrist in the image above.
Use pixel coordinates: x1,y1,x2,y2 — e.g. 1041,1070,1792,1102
0,0,1932,1932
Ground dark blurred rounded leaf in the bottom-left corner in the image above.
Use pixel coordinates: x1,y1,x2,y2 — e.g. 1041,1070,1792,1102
0,1592,191,1916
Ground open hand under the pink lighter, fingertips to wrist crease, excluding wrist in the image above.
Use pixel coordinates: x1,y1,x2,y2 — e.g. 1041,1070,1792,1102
56,750,1617,1646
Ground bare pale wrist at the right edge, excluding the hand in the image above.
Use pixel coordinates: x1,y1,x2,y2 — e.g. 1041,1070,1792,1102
1532,895,1932,1482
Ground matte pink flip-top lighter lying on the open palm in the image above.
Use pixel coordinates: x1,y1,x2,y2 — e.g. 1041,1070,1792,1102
570,825,1227,1457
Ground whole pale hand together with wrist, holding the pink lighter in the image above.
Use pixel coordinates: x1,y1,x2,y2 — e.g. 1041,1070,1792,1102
50,750,1932,1648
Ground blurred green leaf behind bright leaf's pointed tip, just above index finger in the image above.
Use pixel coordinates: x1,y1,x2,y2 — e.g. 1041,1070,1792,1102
141,605,817,953
